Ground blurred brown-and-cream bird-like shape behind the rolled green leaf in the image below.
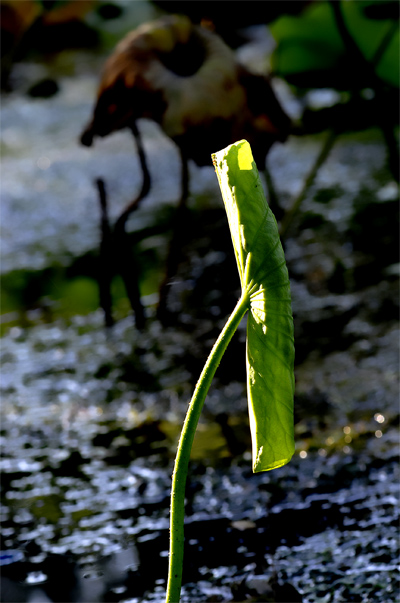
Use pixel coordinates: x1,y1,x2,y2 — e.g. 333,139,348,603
81,15,291,326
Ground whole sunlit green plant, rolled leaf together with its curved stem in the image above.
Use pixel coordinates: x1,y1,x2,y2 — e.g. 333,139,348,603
166,140,294,603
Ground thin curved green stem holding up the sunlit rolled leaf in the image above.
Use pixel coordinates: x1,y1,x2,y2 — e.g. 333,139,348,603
166,291,249,603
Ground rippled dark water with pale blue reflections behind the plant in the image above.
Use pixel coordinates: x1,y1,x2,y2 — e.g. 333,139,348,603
1,22,399,603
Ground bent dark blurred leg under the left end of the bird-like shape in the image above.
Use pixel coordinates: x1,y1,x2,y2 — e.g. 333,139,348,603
114,123,151,329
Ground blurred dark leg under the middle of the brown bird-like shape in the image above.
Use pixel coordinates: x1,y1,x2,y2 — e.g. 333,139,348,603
157,149,189,326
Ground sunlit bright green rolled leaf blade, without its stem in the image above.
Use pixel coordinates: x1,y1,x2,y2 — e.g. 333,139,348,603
213,140,294,472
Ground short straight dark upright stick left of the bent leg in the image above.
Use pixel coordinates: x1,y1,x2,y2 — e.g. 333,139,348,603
96,178,114,327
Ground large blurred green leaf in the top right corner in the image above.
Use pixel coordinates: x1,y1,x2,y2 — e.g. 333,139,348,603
270,0,400,90
